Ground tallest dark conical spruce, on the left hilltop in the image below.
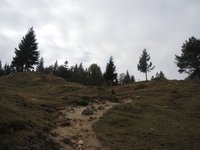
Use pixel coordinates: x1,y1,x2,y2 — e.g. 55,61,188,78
12,27,40,72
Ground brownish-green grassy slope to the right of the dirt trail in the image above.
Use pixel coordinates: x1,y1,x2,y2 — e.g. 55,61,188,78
94,81,200,150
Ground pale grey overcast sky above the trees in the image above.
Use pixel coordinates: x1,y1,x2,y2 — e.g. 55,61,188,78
0,0,200,80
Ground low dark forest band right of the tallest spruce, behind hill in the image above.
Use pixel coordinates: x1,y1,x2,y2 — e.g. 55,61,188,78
36,56,135,86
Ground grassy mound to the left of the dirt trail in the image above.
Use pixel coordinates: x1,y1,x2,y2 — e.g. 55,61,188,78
0,73,114,149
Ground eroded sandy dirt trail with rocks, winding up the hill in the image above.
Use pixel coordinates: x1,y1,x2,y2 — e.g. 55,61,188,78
52,102,118,150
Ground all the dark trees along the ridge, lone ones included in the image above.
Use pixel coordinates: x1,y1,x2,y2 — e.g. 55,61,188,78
0,27,200,82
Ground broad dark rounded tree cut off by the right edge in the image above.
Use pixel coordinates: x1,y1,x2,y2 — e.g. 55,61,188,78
175,37,200,79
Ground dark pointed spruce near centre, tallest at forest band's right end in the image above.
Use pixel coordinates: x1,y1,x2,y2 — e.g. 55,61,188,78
104,56,117,86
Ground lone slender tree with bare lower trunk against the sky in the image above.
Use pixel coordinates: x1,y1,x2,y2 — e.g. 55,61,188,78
137,49,155,81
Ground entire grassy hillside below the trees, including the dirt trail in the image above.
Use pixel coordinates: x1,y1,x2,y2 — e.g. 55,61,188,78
0,73,200,150
